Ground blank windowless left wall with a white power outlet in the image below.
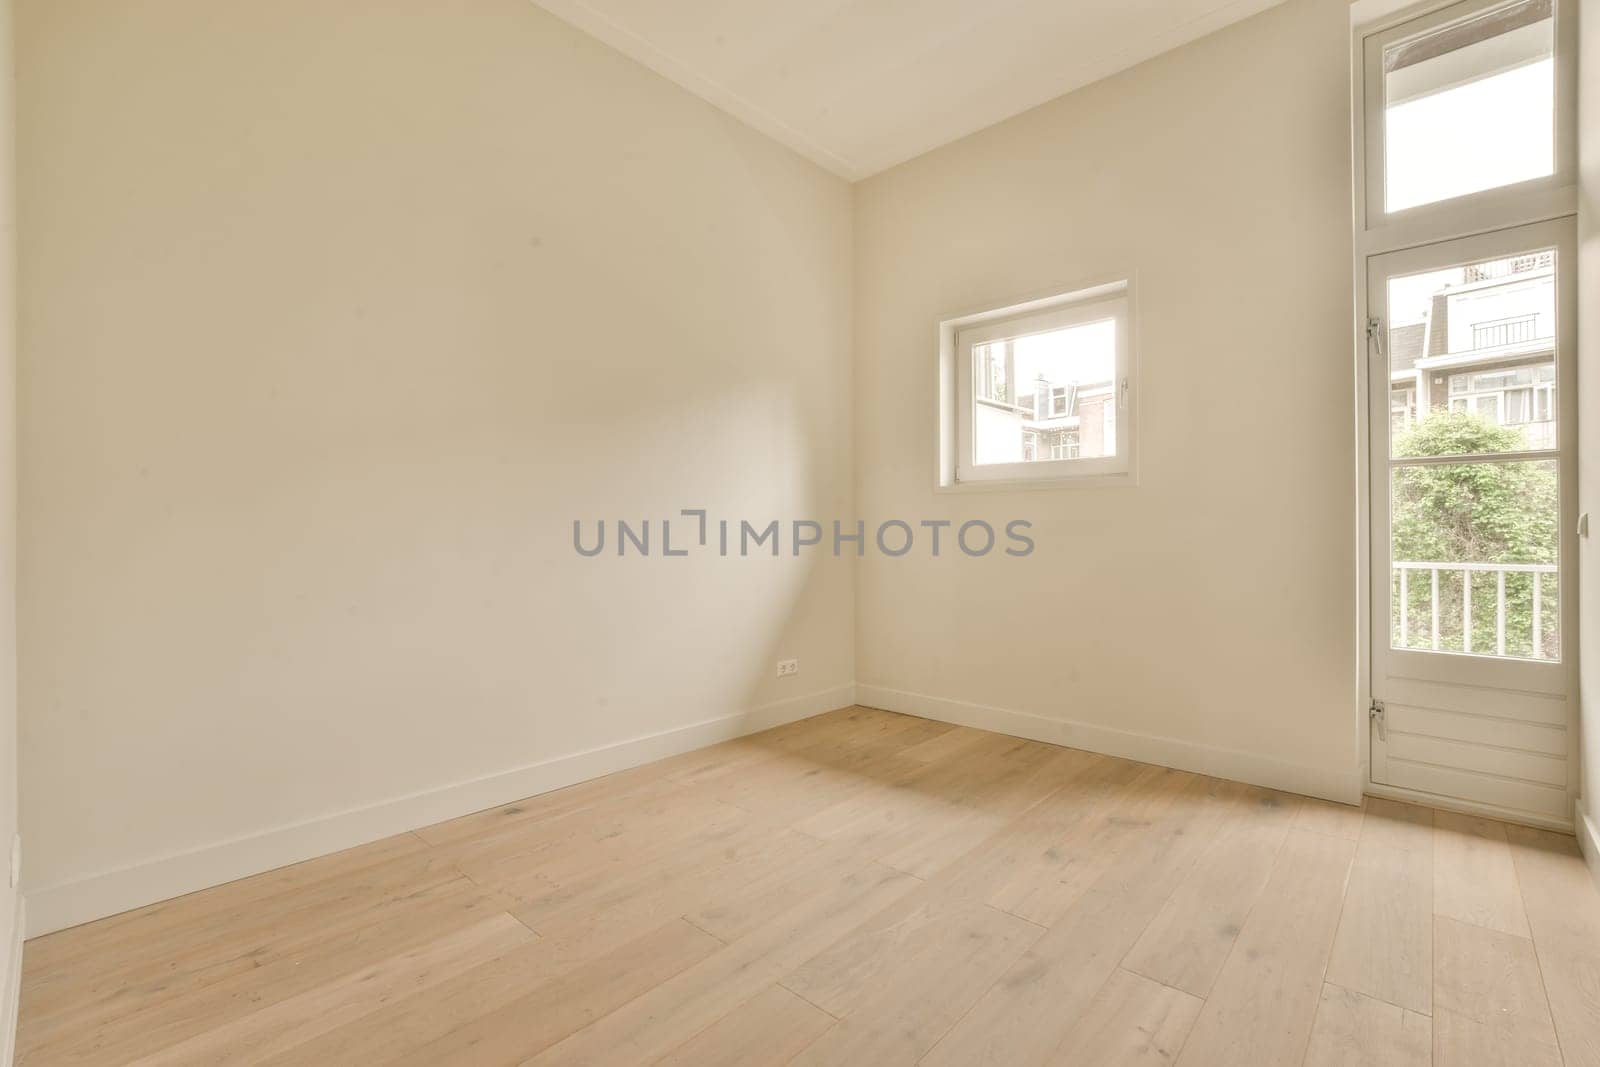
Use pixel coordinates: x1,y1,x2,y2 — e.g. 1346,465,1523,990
18,0,854,933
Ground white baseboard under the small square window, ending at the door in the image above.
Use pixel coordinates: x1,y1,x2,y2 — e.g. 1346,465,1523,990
856,683,1362,805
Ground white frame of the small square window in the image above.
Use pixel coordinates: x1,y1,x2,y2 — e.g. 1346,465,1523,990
938,272,1138,490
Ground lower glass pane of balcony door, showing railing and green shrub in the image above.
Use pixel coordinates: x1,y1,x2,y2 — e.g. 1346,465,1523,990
1389,461,1562,659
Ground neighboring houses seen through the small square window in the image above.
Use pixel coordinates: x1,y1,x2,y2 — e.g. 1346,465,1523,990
973,342,1117,464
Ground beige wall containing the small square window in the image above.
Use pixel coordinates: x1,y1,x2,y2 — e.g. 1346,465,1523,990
856,0,1358,798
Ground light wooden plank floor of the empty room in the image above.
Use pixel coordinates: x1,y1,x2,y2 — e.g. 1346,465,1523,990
19,709,1600,1067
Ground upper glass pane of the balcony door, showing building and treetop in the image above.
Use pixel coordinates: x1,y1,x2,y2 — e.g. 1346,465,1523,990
1387,250,1557,458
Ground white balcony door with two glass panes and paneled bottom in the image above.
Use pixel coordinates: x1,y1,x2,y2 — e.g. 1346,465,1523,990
1366,218,1576,825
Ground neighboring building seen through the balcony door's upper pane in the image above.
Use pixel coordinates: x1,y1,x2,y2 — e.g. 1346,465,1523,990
1389,253,1557,448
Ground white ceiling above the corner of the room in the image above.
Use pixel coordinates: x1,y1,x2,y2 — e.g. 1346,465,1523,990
534,0,1280,181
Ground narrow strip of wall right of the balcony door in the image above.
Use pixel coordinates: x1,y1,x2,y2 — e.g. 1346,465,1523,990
1578,0,1600,881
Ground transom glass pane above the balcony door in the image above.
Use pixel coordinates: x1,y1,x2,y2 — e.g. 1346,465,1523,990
1384,0,1555,211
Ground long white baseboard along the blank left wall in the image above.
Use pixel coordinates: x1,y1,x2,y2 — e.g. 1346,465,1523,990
27,685,856,937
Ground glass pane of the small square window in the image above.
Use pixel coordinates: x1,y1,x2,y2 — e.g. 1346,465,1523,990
973,318,1117,464
